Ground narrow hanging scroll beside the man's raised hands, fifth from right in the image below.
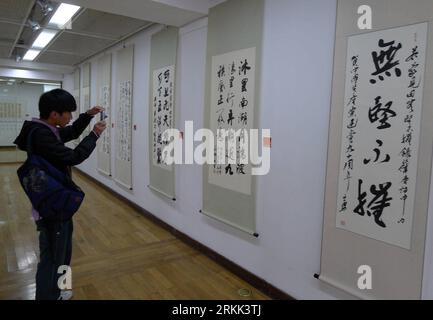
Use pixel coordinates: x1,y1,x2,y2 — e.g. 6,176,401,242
97,54,111,176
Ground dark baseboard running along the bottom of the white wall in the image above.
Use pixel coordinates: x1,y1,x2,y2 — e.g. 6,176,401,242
74,168,295,300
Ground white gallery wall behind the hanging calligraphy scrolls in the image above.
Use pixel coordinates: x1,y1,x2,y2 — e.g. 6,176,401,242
64,0,433,299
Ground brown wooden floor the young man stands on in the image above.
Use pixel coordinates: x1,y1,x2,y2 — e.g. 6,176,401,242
0,164,268,300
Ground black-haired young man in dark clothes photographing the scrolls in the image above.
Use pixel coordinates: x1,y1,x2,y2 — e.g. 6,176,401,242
14,89,106,300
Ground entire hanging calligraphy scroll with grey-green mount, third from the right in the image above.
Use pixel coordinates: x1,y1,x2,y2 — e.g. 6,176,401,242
149,27,179,200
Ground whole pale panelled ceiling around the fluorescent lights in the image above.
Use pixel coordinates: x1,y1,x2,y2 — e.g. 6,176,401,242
0,0,225,72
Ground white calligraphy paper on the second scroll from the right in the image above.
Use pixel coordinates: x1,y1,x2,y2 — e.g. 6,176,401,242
209,48,256,195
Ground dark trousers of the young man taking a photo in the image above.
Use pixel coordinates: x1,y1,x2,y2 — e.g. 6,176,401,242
36,219,73,300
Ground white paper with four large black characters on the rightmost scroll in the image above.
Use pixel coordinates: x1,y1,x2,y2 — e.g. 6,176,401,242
336,23,427,249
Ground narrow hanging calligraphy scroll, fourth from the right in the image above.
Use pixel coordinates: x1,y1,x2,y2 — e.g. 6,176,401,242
114,46,134,189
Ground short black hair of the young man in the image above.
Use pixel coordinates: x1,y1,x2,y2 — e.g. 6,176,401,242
39,89,77,119
